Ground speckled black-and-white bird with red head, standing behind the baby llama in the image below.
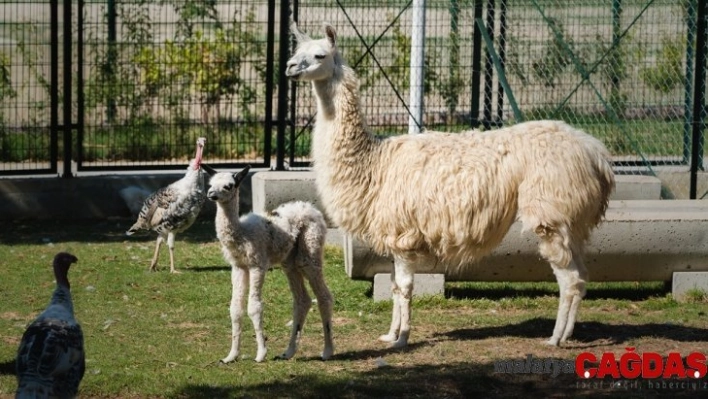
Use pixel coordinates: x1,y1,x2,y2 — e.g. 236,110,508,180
126,137,209,273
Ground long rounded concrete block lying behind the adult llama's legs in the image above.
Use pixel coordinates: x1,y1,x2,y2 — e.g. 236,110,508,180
344,200,708,281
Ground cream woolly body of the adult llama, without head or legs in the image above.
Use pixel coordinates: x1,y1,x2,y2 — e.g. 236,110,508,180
313,114,614,265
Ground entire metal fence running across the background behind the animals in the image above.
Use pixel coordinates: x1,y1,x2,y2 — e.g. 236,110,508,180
0,0,708,198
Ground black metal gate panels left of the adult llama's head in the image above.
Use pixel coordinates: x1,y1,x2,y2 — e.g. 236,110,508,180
0,0,276,177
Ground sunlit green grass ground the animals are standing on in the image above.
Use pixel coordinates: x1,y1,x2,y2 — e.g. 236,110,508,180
0,220,708,398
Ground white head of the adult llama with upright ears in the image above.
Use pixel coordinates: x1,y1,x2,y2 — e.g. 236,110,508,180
285,23,342,81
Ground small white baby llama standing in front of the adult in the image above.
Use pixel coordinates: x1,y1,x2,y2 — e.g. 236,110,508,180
207,167,334,363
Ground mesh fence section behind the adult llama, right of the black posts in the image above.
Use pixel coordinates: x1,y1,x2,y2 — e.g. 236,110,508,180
293,0,708,198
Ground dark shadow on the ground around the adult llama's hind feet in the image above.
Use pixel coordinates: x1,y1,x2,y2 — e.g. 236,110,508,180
436,318,708,345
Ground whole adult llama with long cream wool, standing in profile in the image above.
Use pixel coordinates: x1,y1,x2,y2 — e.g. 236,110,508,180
286,25,615,347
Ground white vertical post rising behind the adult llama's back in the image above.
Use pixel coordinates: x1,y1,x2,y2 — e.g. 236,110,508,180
408,0,425,134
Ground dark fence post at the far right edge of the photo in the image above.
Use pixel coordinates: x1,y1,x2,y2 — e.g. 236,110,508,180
690,0,708,199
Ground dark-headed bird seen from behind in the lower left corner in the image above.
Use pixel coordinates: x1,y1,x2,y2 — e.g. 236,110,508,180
16,252,85,398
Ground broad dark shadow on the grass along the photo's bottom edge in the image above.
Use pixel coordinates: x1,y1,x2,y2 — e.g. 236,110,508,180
172,359,696,399
